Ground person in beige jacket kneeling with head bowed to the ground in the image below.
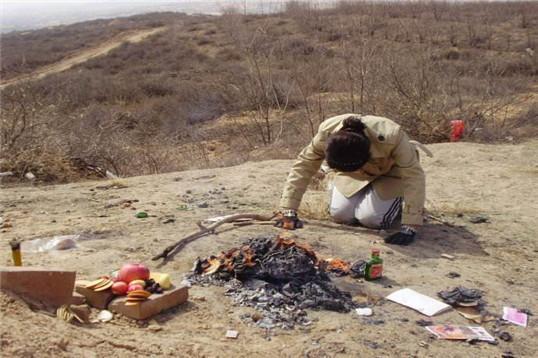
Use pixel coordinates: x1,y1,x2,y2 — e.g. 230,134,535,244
280,114,425,245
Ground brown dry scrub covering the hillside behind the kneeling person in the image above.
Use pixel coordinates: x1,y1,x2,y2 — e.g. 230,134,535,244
0,2,538,181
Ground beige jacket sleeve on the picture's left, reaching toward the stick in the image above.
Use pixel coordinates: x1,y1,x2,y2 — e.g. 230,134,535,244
280,130,327,210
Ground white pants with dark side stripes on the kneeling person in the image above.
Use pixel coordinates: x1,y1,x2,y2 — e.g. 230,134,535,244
329,185,402,229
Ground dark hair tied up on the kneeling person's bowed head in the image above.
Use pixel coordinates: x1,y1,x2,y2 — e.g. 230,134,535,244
325,117,370,172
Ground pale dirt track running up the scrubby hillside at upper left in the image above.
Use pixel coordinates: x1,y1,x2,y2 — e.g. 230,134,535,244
0,27,166,89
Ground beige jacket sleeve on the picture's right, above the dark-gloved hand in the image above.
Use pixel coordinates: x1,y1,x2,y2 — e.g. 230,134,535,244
393,130,426,225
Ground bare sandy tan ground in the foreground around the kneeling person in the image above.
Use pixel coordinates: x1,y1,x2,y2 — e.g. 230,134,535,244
0,140,538,357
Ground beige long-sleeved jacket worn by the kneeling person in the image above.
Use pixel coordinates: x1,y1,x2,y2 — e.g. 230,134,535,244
280,114,426,225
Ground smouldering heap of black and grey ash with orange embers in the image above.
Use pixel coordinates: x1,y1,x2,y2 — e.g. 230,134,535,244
188,236,357,329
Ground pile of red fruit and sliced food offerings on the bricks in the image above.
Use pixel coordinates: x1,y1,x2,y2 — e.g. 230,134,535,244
86,264,172,305
